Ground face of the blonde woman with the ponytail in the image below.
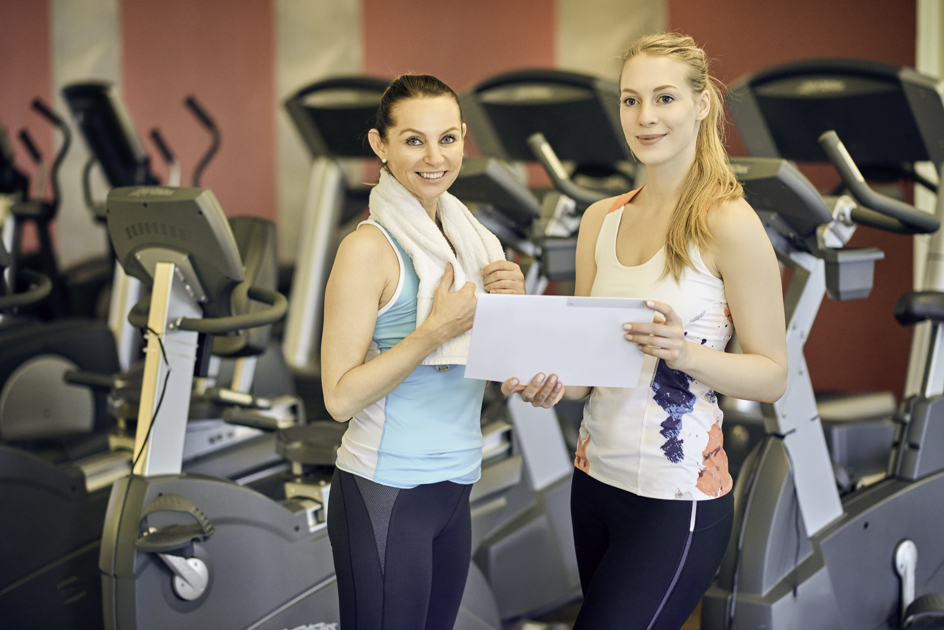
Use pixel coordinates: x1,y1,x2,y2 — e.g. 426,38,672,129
620,54,709,174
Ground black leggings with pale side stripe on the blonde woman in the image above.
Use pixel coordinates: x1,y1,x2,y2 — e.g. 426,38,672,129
570,470,734,630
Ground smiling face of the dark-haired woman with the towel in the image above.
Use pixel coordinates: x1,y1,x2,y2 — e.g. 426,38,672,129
368,96,465,217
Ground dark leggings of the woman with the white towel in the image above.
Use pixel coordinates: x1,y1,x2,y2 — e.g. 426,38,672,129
328,469,472,630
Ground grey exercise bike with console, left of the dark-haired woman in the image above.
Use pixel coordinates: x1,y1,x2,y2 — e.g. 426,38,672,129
100,187,337,629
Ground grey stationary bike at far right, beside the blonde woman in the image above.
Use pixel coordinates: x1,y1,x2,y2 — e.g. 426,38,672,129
702,132,944,629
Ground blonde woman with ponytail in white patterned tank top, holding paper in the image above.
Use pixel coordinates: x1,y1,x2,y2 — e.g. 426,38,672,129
503,33,787,630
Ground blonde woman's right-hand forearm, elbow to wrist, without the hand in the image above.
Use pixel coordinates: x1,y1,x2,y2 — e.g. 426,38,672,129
680,342,787,403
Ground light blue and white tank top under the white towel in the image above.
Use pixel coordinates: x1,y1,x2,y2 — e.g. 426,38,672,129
337,222,485,488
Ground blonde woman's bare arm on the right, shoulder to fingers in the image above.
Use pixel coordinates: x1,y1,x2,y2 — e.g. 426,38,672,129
624,200,787,402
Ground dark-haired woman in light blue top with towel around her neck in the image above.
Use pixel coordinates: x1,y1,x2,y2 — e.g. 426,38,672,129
321,75,524,630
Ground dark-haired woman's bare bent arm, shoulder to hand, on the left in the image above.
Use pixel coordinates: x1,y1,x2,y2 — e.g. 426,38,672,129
321,228,475,422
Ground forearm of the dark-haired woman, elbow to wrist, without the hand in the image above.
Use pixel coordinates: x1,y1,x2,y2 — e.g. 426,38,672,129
323,326,449,422
